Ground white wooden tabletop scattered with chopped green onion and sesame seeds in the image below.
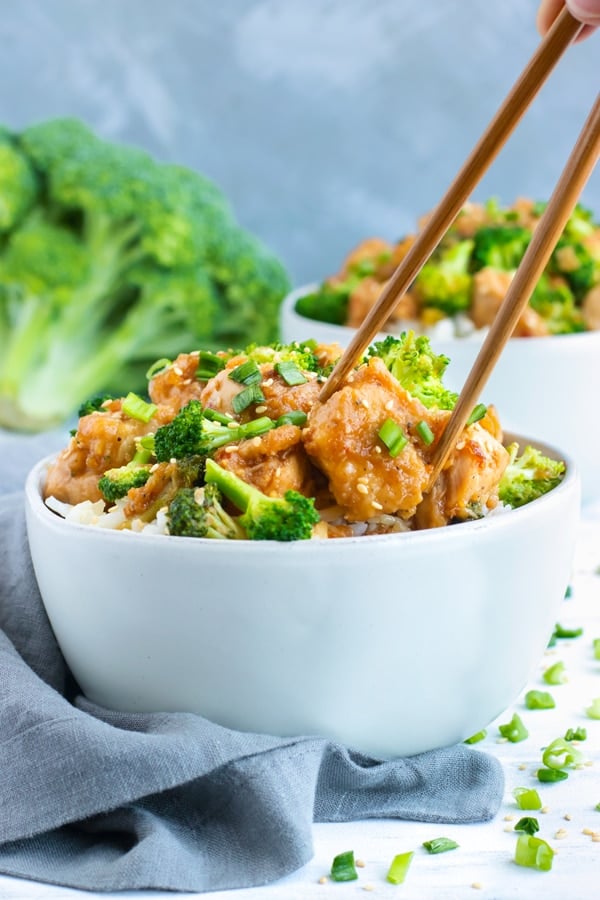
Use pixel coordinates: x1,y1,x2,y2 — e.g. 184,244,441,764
0,504,600,900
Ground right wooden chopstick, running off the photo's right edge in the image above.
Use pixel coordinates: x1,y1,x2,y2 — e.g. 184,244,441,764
429,94,600,489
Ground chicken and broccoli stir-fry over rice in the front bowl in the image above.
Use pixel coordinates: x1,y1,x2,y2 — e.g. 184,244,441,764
44,332,565,541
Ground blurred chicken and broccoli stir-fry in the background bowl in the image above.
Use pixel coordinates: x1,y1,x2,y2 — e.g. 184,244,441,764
296,199,600,338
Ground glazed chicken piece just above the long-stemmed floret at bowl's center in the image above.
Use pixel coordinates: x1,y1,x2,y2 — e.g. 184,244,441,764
214,425,314,497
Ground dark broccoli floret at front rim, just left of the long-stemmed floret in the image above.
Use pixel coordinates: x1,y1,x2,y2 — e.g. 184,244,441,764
167,484,246,540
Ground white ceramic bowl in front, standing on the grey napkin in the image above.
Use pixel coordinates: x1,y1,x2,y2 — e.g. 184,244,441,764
26,438,579,757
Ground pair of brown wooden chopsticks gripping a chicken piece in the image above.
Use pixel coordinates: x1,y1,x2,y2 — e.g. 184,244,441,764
319,7,600,489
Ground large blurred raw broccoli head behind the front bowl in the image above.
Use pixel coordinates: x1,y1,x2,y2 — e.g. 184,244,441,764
0,119,289,430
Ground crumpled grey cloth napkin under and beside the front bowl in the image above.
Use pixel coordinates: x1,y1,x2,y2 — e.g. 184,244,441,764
0,438,503,892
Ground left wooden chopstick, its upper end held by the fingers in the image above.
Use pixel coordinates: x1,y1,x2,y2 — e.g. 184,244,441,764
319,7,583,402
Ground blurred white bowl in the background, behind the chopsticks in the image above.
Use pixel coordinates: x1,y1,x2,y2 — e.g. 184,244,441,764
280,285,600,503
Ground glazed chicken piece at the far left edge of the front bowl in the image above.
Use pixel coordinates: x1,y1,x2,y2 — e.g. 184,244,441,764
44,400,171,504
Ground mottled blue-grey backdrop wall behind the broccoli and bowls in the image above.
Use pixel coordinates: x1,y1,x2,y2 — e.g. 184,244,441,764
0,0,600,283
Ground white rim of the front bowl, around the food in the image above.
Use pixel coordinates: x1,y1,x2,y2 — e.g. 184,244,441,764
25,432,580,556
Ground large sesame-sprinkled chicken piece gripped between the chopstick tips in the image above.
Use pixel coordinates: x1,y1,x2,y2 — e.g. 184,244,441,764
302,358,442,521
